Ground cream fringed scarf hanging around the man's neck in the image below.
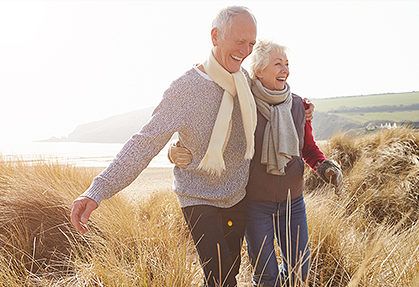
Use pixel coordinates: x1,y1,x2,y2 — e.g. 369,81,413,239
198,53,257,176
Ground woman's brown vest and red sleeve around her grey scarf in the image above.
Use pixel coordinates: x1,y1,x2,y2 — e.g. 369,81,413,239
246,94,326,202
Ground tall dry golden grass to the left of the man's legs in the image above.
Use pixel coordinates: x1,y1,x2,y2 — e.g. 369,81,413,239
0,162,201,286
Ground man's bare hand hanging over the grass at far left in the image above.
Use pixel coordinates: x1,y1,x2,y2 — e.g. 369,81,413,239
70,196,98,234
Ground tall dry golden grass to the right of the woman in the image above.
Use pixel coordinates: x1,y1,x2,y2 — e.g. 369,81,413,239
306,128,419,286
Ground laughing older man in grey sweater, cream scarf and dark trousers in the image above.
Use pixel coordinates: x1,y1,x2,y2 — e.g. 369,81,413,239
71,7,256,287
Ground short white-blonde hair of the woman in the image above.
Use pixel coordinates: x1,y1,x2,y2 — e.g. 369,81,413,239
249,40,286,80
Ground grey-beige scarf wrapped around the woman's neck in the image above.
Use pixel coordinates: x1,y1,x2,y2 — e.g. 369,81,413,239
252,80,300,175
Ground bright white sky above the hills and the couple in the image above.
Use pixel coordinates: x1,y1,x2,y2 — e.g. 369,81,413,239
0,0,419,142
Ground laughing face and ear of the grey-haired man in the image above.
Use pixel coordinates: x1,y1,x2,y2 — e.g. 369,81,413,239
211,14,256,73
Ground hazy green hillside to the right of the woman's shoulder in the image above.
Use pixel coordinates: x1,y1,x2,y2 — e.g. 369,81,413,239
312,92,419,140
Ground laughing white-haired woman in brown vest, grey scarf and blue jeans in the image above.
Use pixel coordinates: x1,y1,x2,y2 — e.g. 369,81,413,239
169,41,342,286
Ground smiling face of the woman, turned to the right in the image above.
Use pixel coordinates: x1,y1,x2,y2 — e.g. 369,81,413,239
256,51,289,91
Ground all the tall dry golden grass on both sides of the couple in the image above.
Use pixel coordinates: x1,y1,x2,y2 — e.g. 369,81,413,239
0,128,419,287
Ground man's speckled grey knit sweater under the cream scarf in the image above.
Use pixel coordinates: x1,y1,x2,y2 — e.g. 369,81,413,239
82,69,250,208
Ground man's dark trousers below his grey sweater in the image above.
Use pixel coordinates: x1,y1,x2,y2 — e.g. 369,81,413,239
182,200,246,287
